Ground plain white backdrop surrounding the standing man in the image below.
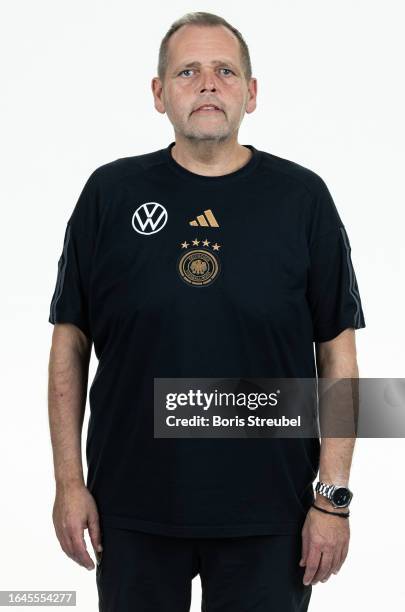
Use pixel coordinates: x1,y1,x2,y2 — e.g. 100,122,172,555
0,0,405,612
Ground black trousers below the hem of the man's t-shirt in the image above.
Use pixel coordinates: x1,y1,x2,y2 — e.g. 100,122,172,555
96,526,312,612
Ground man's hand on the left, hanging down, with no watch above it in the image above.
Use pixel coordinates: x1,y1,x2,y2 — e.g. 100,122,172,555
52,483,102,570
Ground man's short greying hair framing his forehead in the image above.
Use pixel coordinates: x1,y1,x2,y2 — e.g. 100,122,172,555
158,12,252,81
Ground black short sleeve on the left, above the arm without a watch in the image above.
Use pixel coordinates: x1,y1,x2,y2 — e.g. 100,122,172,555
48,172,98,340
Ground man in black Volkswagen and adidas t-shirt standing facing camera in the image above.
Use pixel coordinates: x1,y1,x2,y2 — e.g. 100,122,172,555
49,13,365,612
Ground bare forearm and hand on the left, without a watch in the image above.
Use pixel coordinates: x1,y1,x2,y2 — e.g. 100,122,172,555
48,323,102,569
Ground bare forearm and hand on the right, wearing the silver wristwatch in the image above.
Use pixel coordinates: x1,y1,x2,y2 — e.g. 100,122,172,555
300,328,359,585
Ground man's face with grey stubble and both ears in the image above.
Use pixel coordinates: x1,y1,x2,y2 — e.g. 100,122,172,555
152,25,256,141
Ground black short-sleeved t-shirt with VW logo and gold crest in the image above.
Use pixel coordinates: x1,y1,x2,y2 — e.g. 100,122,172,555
49,142,365,537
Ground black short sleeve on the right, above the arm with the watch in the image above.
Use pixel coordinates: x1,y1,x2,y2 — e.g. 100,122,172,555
307,181,366,342
